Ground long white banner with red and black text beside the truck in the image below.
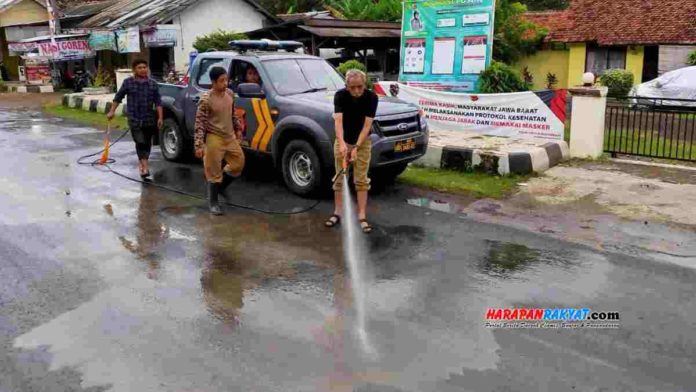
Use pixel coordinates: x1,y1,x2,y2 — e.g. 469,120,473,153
376,82,565,140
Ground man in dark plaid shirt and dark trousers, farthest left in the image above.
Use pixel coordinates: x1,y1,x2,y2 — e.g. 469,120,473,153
106,60,164,179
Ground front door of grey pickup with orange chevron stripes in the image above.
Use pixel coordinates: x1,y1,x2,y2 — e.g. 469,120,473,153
230,59,274,152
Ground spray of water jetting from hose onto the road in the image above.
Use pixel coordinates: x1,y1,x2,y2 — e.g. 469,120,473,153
339,176,376,356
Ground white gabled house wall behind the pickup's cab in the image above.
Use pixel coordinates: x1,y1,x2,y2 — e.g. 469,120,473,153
174,0,265,71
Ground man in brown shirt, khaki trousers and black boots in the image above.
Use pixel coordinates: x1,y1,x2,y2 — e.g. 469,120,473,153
195,67,244,215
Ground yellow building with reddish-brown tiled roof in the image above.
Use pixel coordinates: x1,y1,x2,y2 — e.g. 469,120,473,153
517,0,696,88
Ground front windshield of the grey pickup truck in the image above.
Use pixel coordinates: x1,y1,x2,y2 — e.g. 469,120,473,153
264,59,345,95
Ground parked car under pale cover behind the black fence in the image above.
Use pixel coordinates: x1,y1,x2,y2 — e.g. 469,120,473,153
630,66,696,108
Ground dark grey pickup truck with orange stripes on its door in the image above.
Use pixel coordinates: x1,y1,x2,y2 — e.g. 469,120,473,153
159,41,428,196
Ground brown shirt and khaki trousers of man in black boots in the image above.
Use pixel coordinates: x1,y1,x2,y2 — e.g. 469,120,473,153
195,90,245,183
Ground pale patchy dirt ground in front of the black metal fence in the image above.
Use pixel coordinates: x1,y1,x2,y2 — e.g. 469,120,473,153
462,161,696,267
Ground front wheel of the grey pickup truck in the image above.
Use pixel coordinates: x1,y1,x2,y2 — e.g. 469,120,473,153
282,140,323,196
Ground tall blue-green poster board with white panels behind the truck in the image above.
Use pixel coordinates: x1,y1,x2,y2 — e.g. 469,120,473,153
399,0,495,92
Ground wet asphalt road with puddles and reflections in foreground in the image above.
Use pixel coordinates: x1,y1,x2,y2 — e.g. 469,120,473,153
0,111,696,392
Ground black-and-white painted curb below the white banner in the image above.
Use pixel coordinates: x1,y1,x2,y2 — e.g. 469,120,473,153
415,140,570,176
